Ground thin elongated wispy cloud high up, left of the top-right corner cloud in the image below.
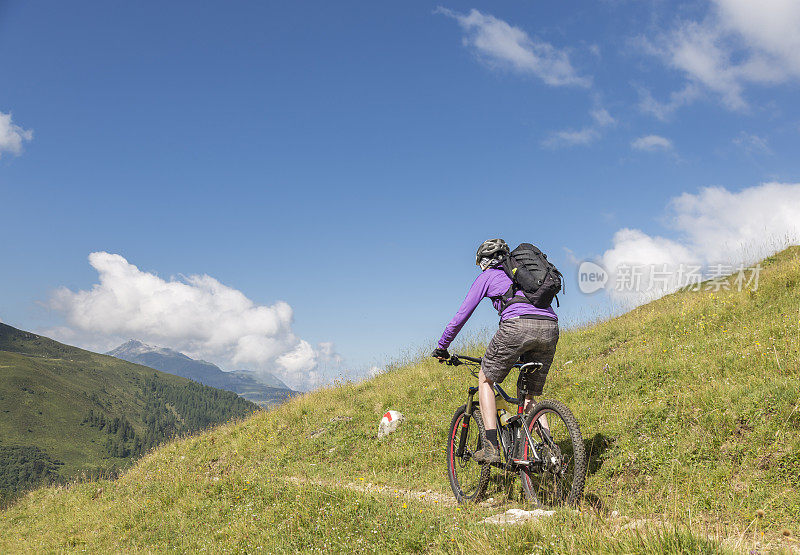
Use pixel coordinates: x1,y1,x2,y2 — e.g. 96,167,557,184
435,7,591,87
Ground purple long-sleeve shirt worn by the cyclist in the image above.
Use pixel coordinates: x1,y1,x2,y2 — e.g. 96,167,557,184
439,268,558,349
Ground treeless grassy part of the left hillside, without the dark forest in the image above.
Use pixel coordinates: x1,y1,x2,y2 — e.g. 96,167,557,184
0,324,255,486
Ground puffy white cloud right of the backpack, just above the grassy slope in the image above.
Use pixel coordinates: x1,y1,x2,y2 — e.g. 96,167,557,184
601,183,800,304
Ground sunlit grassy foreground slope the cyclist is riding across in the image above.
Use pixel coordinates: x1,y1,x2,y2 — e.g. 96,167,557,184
0,248,800,552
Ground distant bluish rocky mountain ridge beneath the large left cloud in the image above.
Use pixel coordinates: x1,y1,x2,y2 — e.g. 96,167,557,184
106,339,298,407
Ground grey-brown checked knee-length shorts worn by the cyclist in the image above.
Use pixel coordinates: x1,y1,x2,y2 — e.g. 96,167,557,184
481,318,558,395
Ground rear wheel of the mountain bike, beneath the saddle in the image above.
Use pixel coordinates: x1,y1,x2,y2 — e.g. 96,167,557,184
520,400,586,507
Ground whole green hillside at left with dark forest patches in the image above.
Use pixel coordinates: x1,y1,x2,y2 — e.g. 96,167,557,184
0,323,258,505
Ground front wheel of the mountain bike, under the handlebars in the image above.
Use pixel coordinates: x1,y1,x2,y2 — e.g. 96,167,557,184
447,405,490,503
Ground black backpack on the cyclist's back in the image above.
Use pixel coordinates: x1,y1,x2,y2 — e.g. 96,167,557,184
499,243,564,314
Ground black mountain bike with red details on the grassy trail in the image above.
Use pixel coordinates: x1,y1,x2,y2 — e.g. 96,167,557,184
446,355,586,507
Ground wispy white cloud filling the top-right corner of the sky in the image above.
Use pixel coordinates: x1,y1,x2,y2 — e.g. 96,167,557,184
643,0,800,115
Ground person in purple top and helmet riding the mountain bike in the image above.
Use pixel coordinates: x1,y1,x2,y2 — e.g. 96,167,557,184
432,239,558,464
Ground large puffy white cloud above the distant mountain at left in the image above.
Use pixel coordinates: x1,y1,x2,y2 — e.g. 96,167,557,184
50,252,341,389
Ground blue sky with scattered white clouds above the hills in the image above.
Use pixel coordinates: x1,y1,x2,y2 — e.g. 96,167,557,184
0,0,800,387
